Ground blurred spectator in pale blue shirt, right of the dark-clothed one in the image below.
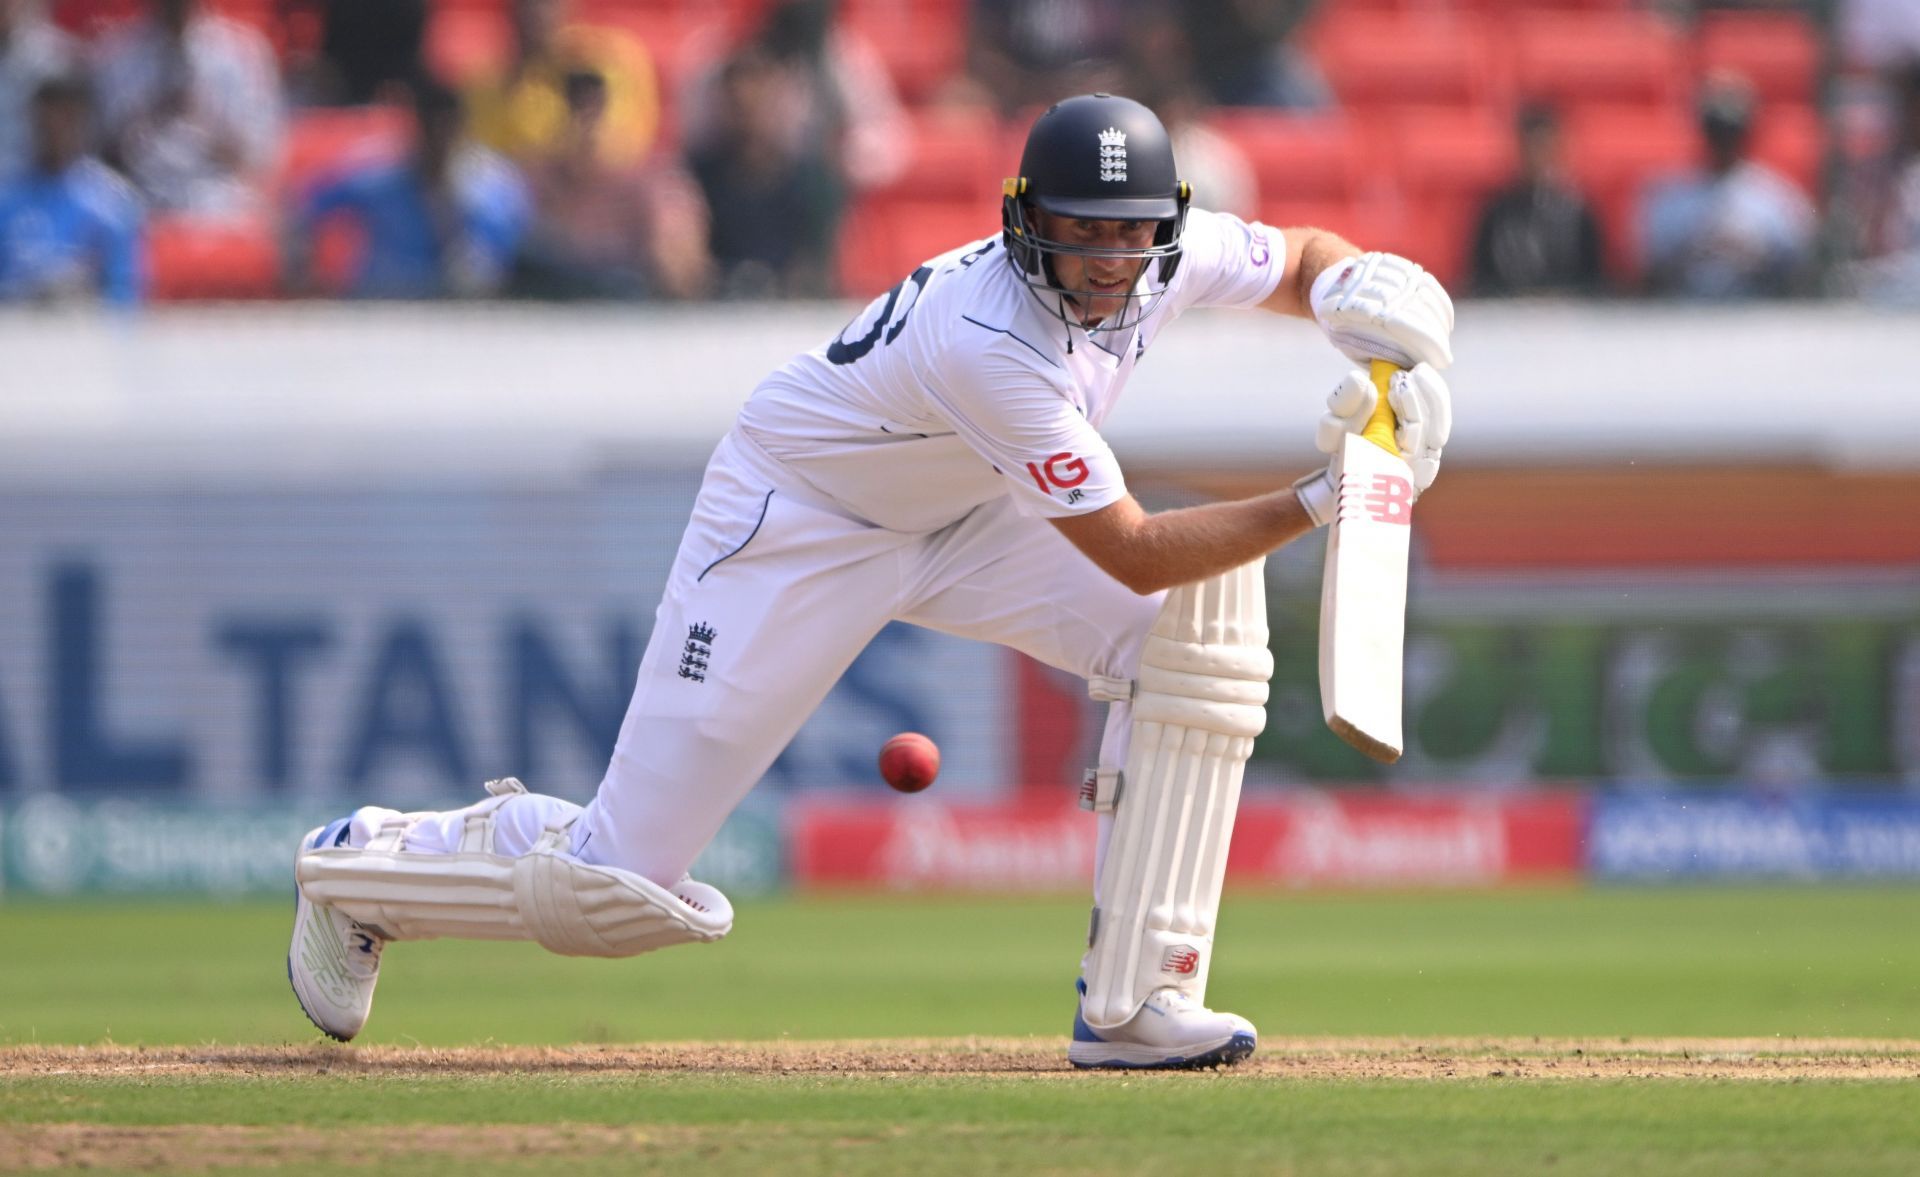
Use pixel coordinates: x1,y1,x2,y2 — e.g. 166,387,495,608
1642,75,1816,300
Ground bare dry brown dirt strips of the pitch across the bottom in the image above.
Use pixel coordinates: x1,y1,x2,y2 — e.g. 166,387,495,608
0,1039,1920,1173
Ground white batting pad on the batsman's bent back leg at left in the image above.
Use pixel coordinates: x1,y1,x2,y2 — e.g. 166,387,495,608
296,797,733,956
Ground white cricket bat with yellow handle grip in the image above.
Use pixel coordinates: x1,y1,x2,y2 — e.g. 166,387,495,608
1321,359,1413,764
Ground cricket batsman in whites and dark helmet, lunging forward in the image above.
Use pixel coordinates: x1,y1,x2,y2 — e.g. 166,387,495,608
286,94,1453,1068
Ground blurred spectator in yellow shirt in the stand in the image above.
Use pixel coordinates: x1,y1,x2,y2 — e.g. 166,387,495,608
467,0,660,167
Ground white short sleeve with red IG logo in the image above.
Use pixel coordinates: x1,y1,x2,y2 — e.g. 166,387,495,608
927,336,1127,518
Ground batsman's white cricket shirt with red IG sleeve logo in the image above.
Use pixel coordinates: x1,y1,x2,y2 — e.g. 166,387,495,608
739,209,1286,532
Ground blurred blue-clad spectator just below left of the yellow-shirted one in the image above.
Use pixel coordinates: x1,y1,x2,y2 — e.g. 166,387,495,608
288,79,528,298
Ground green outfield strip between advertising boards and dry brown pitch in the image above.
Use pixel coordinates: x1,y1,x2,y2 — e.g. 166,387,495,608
0,887,1920,1046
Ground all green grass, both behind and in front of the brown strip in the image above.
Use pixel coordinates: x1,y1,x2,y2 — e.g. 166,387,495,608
0,887,1920,1175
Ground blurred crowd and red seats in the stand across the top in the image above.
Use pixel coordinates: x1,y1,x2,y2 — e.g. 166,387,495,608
0,0,1920,305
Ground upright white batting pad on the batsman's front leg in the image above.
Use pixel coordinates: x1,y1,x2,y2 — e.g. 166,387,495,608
1081,559,1273,1029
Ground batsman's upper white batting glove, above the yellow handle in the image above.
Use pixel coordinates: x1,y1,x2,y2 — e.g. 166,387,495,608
1311,253,1453,369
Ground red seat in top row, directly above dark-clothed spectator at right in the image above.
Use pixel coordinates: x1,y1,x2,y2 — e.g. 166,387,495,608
1513,12,1692,106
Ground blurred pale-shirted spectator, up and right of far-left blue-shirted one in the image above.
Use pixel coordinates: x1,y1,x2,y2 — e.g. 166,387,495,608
96,0,282,215
